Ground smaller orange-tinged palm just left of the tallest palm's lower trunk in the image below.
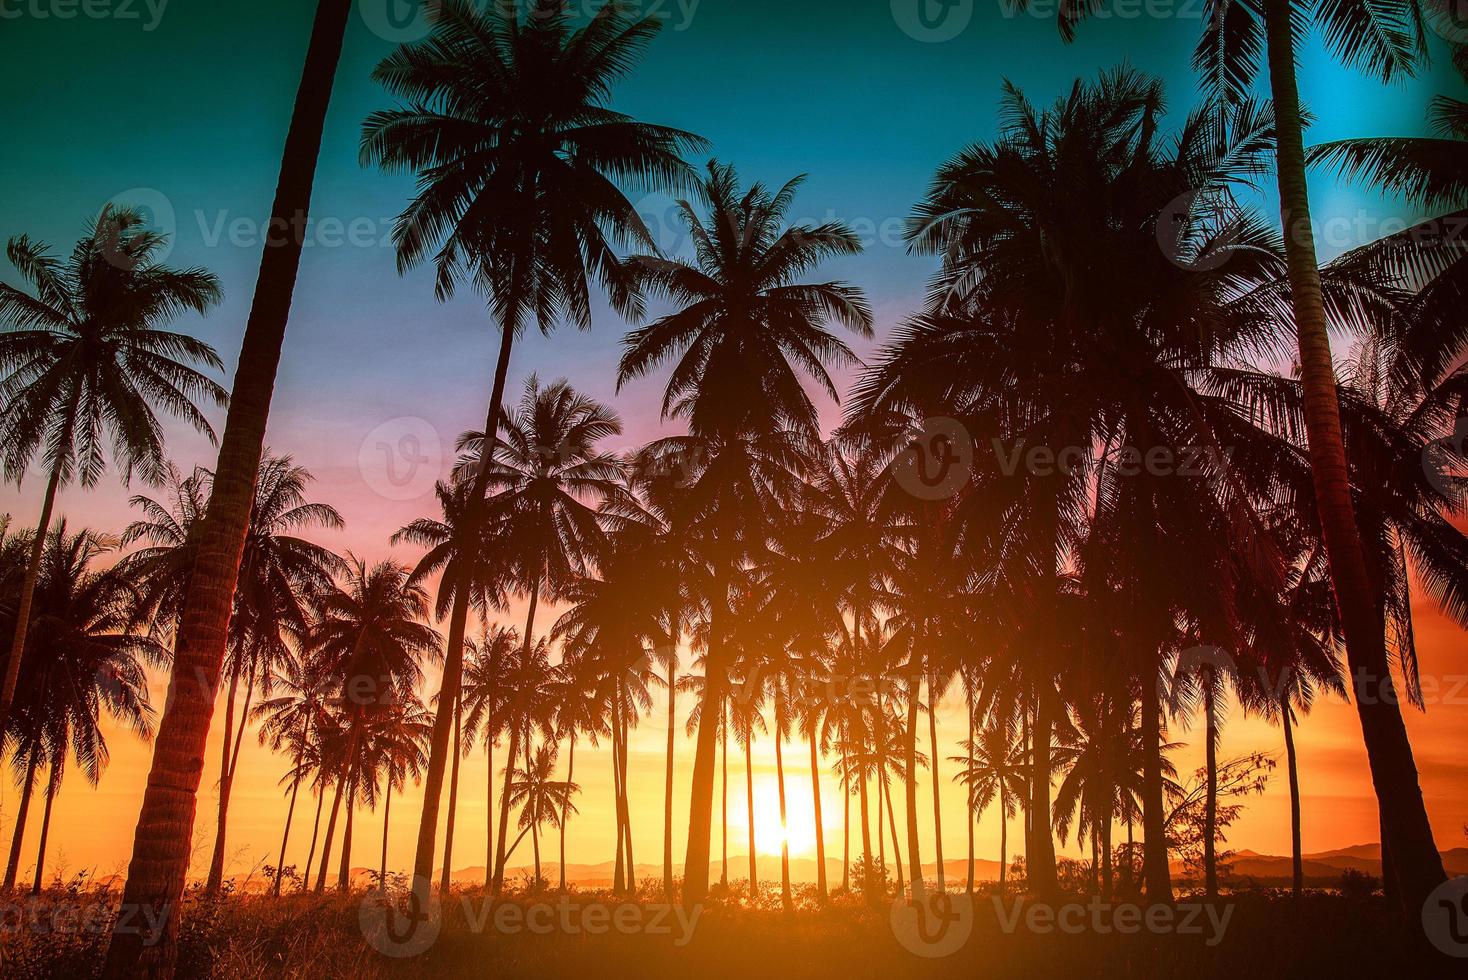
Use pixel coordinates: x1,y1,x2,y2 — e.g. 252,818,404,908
311,556,442,892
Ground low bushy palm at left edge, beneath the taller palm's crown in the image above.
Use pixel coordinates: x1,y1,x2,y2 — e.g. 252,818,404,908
0,521,167,893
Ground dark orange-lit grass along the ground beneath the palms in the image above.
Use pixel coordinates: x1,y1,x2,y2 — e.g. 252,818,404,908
0,885,1444,980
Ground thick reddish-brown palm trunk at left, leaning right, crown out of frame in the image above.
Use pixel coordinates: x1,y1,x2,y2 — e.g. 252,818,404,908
103,0,352,980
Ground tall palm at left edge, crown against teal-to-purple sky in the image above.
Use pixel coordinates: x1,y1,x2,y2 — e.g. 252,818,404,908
0,208,228,742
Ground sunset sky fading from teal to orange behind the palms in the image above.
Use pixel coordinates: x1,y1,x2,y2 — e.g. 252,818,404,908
0,0,1468,874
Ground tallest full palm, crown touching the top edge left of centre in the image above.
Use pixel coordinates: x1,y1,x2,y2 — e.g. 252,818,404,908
361,0,702,882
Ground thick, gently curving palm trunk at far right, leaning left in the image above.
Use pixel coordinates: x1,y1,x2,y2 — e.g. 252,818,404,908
1264,0,1447,920
